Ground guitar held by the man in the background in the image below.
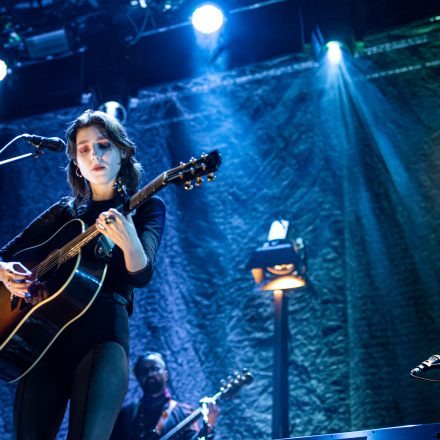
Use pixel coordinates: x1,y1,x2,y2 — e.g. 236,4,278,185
156,368,254,440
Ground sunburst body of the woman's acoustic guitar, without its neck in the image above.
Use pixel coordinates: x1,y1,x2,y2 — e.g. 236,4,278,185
0,219,107,382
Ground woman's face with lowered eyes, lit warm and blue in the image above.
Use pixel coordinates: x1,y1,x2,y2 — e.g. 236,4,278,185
76,125,121,190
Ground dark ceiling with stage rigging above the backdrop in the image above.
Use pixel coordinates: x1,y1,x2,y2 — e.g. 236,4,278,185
0,0,440,120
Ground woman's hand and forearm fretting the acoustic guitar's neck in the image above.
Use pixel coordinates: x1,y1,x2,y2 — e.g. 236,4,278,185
96,208,147,272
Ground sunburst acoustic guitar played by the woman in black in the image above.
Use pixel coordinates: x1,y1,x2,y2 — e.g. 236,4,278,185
0,150,221,382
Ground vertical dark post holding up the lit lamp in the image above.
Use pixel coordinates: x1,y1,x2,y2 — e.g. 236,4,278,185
272,290,289,439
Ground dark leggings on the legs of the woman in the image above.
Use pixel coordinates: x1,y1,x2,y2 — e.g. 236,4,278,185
14,342,128,440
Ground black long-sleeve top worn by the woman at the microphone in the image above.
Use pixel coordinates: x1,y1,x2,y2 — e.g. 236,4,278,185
0,196,165,376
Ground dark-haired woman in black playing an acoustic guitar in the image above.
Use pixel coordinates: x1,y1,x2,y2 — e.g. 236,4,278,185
0,110,165,440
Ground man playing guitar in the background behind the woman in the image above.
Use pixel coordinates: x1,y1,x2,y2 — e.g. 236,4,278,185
111,352,219,440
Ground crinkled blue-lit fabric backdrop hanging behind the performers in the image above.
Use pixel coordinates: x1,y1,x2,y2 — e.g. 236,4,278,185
0,23,440,440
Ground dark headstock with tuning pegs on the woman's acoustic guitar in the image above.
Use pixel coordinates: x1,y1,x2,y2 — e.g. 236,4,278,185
163,150,222,191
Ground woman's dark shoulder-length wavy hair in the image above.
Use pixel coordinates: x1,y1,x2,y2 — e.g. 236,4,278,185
66,110,142,205
